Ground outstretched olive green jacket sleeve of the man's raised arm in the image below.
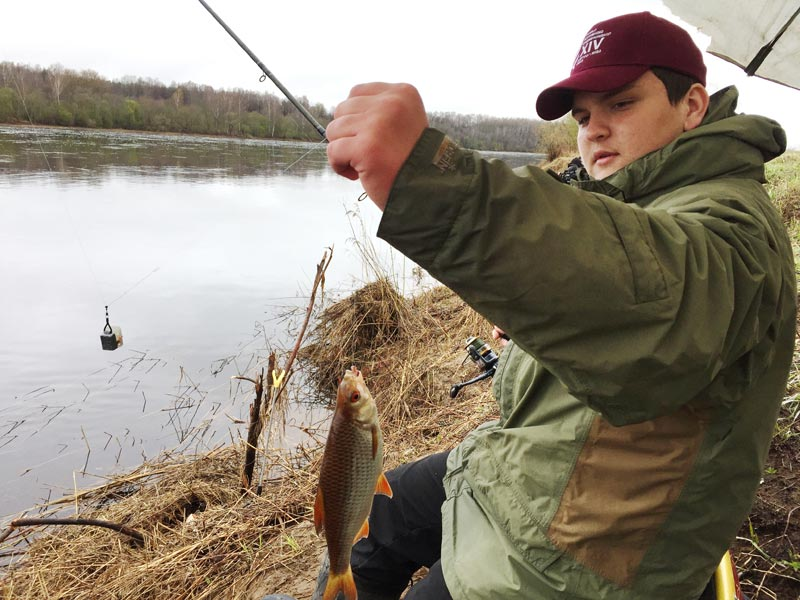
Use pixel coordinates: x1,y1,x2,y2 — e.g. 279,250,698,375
378,129,787,424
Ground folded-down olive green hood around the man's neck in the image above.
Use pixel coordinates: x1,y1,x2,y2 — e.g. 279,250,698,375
577,86,786,203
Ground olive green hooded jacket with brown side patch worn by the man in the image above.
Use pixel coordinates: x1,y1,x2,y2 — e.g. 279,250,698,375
378,88,796,600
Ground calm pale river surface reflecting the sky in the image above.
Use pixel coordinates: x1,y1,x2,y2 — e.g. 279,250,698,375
0,125,540,520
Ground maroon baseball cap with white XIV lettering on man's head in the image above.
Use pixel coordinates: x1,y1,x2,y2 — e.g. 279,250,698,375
536,12,706,121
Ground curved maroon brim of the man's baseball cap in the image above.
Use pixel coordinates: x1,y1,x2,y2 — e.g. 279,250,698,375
536,65,650,121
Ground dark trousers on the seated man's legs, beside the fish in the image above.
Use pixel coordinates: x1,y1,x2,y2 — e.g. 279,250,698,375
350,452,452,600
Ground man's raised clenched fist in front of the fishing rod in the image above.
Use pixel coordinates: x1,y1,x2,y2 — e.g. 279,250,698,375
325,83,428,210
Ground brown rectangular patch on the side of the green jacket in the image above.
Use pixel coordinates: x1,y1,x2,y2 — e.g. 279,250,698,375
548,408,705,587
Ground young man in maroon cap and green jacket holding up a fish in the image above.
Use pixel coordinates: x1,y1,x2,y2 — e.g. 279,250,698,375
278,13,796,600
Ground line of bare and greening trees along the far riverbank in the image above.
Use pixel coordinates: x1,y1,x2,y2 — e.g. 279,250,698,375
0,62,574,155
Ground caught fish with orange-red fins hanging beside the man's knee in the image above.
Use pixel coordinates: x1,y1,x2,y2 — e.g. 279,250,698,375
314,367,392,600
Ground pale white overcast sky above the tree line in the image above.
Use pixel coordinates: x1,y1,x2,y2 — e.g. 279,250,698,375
0,0,800,148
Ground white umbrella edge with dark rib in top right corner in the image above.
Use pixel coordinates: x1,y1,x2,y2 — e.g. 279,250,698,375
664,0,800,89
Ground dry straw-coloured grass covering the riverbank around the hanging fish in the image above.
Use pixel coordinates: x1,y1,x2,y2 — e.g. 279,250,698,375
0,278,494,600
